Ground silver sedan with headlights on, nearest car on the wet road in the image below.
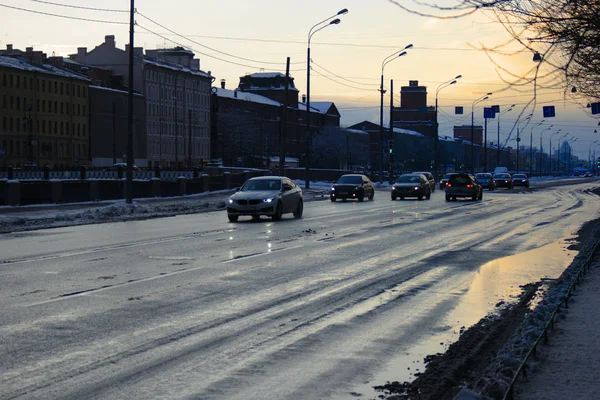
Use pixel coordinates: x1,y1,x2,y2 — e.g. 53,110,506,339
227,176,304,222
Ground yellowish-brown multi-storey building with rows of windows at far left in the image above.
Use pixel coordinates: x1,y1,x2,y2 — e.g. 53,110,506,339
0,45,90,168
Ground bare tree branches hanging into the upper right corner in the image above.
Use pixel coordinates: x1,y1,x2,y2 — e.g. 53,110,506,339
388,0,600,99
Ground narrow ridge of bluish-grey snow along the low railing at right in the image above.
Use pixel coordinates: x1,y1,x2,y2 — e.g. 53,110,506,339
455,229,600,400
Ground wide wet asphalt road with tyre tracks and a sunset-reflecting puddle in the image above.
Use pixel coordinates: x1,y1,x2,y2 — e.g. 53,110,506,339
0,182,600,399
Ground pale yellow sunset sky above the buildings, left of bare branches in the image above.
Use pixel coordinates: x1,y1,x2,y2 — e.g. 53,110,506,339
0,0,600,159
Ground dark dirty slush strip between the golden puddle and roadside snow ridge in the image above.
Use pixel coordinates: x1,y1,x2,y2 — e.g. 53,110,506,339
374,203,600,400
